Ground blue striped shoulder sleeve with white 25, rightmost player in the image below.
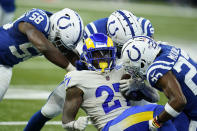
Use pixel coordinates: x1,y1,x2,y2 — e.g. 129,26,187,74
146,45,180,86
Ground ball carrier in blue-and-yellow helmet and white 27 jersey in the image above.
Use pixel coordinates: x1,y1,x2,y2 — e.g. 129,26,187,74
62,34,189,131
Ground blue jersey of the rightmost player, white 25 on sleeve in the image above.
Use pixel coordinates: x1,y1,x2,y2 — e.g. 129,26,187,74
147,45,197,120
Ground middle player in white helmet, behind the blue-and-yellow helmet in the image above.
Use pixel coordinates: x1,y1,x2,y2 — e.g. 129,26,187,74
77,10,154,58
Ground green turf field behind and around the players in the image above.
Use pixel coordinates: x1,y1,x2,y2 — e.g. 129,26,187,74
0,0,197,131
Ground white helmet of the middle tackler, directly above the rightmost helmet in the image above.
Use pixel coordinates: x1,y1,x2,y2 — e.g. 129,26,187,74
107,10,142,46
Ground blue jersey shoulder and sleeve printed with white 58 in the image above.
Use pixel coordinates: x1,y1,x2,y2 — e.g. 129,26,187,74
15,9,50,36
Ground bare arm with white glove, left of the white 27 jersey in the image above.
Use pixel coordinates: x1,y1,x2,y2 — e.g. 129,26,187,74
62,87,88,130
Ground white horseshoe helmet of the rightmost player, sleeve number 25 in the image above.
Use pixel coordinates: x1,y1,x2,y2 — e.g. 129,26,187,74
122,36,161,79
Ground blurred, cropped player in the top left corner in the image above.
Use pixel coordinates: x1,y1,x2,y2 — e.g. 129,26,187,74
0,0,16,26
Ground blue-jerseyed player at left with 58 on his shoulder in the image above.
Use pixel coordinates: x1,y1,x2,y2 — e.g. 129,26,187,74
0,8,83,100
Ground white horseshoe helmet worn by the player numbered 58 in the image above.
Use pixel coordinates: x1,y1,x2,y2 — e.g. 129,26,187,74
49,8,84,51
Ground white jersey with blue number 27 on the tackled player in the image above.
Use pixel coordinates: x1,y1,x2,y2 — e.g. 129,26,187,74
65,68,130,129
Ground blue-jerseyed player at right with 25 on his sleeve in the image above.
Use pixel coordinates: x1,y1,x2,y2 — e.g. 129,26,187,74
122,36,197,131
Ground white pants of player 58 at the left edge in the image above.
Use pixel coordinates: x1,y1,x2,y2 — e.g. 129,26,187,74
0,65,12,101
